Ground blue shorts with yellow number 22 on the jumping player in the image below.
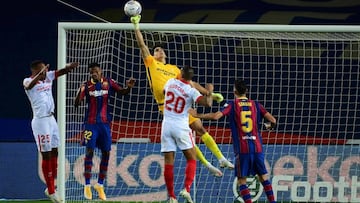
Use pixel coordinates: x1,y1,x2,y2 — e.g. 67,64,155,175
83,123,112,152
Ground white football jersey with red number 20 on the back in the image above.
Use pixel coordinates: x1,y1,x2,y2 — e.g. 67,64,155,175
164,78,202,125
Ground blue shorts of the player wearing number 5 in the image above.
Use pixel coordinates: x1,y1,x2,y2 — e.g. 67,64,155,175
235,153,267,177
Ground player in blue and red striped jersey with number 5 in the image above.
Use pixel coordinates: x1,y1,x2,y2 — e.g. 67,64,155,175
189,80,276,203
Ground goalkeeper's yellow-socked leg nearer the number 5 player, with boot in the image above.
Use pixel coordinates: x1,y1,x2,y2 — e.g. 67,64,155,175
190,119,234,169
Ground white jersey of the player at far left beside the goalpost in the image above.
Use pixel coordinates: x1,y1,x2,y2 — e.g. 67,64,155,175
23,71,55,118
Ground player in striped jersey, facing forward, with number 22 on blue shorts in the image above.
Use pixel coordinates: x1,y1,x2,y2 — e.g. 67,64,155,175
74,63,135,200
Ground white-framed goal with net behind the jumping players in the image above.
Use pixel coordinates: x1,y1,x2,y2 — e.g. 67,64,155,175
57,23,360,202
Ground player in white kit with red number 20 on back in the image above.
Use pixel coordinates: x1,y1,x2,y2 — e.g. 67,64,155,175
161,66,214,202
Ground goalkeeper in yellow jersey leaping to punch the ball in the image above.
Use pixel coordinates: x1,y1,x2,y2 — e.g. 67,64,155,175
131,15,234,177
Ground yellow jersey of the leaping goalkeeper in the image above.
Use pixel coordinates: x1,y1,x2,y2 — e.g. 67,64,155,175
144,55,181,112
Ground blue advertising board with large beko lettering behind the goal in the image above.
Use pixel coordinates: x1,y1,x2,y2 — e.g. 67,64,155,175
0,143,360,202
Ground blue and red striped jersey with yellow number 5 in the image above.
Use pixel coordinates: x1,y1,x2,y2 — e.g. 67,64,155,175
222,97,267,154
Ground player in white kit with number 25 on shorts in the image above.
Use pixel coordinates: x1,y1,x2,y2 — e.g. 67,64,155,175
23,60,79,202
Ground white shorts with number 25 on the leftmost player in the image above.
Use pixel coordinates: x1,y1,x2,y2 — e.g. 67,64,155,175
31,116,60,152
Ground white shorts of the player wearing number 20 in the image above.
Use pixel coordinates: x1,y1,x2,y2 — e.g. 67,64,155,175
161,122,195,152
